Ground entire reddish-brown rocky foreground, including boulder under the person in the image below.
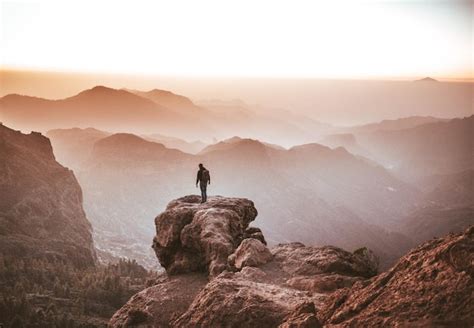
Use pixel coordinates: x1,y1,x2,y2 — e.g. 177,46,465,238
109,196,474,327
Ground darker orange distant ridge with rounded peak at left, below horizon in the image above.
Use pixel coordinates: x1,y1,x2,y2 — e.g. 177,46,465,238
0,86,209,136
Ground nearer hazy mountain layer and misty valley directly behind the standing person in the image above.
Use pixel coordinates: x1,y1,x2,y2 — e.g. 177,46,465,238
48,117,474,268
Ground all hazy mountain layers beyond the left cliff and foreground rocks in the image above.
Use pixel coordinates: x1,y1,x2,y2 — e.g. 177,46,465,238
0,87,473,267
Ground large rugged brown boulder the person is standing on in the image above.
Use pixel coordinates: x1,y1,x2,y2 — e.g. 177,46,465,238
153,196,257,277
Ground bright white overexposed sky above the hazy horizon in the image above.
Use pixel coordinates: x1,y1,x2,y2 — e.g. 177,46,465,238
0,0,473,79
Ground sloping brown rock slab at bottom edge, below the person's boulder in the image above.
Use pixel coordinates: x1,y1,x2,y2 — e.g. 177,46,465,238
173,272,311,327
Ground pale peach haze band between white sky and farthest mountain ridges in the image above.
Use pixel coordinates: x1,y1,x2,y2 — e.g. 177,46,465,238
0,71,473,127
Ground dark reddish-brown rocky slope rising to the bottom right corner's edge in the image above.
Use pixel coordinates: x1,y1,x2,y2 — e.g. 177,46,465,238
319,226,474,327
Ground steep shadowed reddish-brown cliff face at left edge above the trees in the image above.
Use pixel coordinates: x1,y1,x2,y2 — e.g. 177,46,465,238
0,125,96,267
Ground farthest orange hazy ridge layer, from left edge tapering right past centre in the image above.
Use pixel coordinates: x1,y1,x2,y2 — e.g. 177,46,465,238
0,86,331,144
